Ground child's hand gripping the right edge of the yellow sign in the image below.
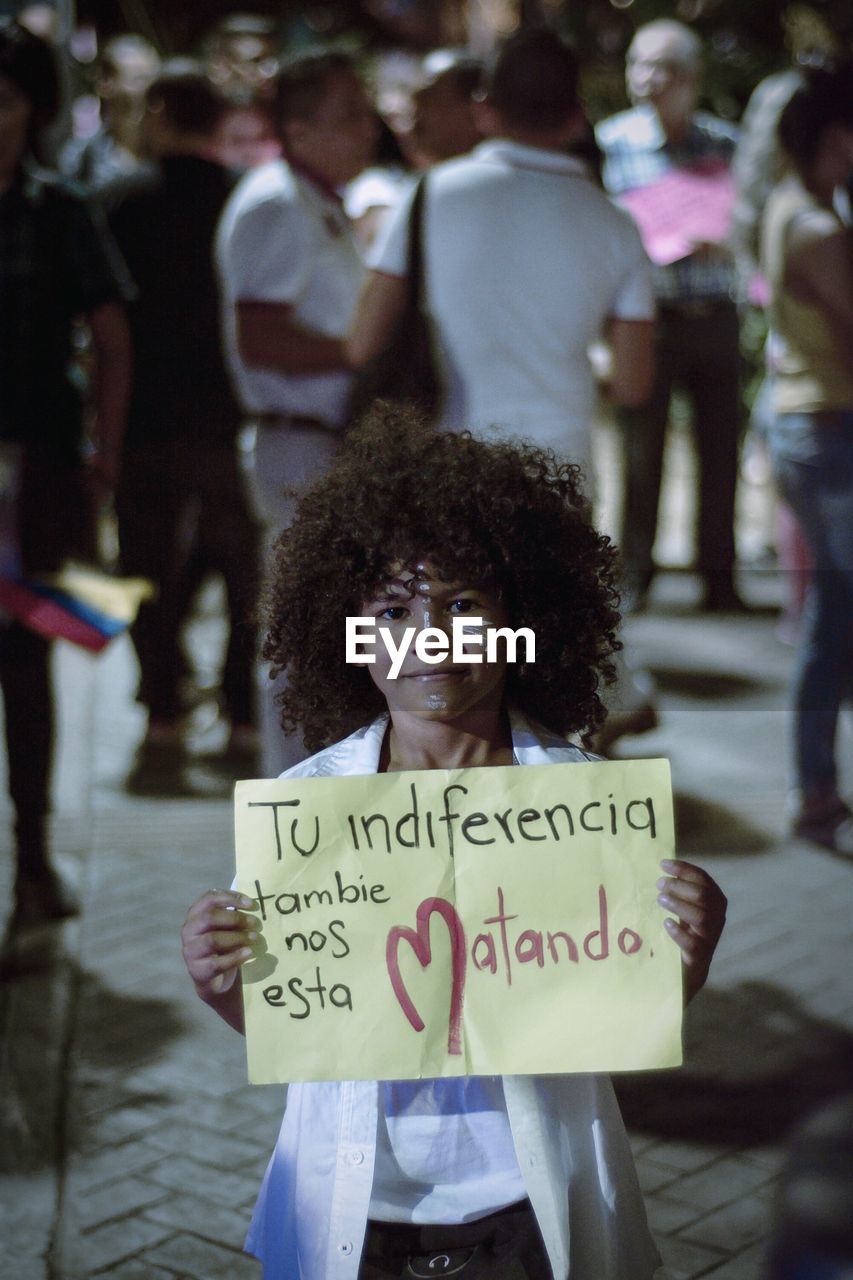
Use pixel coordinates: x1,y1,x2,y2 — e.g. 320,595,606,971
657,859,727,1004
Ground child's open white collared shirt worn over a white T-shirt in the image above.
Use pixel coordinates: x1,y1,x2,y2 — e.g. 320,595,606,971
246,713,660,1280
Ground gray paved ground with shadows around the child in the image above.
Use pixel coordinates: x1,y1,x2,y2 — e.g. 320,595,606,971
0,573,853,1280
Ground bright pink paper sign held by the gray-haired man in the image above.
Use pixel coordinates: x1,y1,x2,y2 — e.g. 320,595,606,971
619,165,734,266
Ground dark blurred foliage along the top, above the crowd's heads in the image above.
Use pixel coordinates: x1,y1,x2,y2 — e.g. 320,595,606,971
77,0,853,119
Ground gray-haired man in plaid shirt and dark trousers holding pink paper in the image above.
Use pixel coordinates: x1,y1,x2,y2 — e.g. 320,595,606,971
597,19,743,611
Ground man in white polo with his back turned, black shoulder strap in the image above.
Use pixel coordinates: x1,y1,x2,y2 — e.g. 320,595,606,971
348,28,657,750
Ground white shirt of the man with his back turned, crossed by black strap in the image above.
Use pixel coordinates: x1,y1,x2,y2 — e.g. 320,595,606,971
369,138,654,470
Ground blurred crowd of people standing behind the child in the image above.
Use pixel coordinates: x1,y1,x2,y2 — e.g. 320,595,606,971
0,4,853,924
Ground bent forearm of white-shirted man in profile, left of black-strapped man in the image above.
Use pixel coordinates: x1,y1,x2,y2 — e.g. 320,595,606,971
237,300,347,375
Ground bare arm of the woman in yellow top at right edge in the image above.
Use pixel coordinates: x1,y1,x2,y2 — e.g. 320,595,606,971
785,211,853,358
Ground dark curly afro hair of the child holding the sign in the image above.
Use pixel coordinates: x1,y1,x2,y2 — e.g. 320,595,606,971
264,403,620,751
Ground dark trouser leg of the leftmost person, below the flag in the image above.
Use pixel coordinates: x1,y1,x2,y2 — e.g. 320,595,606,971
0,622,54,879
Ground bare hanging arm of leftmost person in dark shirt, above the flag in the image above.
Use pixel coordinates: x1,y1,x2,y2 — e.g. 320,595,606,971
87,302,132,489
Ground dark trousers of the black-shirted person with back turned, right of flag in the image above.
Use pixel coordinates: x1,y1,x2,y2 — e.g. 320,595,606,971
117,442,259,724
